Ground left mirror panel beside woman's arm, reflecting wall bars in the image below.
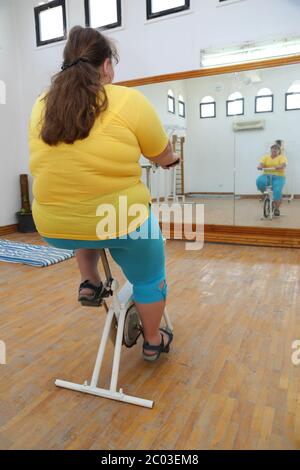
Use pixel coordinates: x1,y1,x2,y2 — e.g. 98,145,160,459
138,78,234,225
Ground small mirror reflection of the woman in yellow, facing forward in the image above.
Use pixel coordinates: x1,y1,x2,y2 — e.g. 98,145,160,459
256,144,287,216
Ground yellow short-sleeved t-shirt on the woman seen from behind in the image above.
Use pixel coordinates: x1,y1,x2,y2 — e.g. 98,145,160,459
29,84,168,240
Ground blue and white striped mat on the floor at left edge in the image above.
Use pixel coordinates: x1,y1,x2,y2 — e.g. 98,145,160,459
0,239,74,268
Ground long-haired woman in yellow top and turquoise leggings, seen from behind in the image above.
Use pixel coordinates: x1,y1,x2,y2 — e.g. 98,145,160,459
29,26,179,361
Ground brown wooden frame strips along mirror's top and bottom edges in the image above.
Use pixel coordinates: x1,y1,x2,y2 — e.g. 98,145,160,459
116,55,300,248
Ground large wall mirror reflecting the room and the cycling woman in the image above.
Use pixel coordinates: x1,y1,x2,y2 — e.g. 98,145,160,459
120,59,300,246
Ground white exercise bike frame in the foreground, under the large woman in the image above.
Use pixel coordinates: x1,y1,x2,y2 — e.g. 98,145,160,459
55,250,173,408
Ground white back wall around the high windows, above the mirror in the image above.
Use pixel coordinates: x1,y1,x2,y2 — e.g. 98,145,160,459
11,0,300,173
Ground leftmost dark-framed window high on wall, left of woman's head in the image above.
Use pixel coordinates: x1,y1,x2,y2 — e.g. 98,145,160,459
34,0,67,46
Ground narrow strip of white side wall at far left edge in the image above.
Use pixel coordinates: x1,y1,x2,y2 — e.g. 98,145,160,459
0,0,23,226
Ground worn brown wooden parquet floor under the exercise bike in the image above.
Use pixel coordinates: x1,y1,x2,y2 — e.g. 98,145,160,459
0,234,300,450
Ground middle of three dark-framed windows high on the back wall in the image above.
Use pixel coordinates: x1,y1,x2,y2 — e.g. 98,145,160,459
84,0,122,29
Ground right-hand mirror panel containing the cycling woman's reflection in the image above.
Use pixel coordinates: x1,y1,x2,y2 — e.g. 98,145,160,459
235,64,300,228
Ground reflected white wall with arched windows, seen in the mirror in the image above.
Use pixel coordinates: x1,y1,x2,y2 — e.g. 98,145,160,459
185,64,300,194
